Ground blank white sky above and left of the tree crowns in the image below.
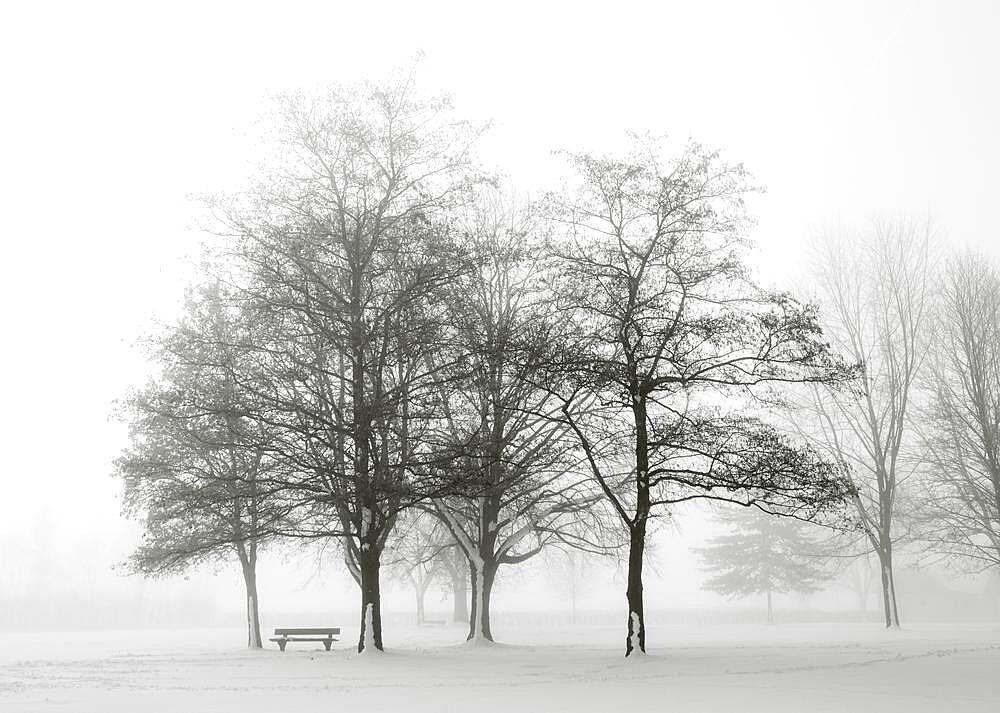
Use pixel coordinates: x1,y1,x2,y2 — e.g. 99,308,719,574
0,0,1000,616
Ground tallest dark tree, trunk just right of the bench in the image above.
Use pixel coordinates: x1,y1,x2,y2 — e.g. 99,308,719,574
216,77,476,651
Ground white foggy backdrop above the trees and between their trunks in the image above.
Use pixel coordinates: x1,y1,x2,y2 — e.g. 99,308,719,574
0,2,1000,640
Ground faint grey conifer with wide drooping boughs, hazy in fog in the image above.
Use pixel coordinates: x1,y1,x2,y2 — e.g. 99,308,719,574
699,508,832,624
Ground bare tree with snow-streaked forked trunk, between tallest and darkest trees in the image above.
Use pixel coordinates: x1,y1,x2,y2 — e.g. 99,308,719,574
434,191,602,641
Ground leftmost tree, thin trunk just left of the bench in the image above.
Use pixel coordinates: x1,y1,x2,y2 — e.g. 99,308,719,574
115,285,289,648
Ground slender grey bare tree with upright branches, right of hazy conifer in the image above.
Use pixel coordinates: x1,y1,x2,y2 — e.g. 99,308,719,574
809,221,933,627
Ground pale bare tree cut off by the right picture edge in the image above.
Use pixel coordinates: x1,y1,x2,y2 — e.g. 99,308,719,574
918,253,1000,571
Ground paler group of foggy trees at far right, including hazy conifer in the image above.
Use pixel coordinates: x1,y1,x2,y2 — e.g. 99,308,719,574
703,220,1000,627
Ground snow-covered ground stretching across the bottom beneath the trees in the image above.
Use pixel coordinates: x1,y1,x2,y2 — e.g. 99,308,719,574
0,622,1000,713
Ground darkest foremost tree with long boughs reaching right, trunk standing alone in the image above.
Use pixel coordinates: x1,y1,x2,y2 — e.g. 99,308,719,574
547,136,850,656
